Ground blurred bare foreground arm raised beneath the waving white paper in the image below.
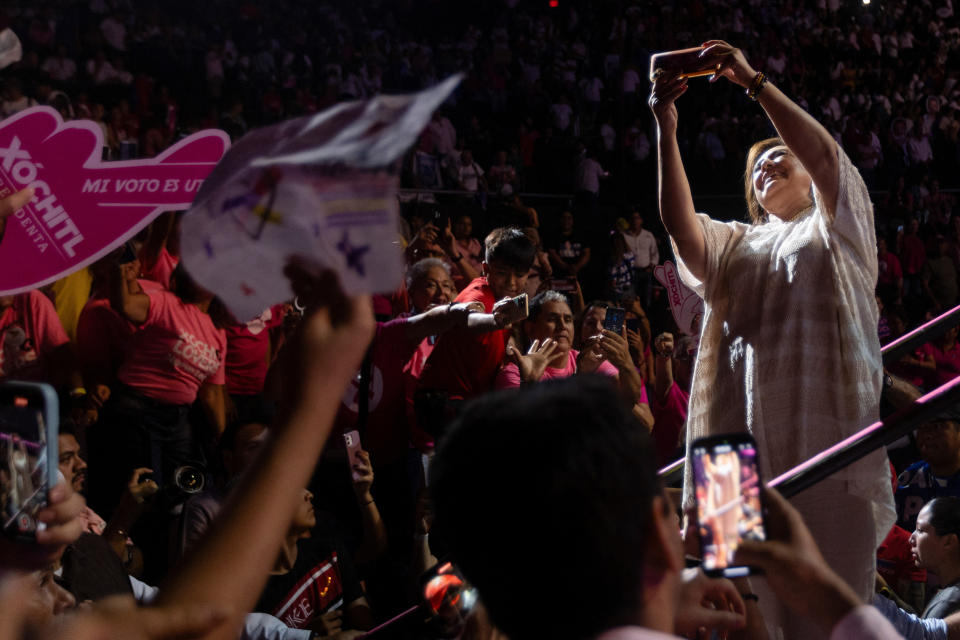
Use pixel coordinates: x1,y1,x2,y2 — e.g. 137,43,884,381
158,273,374,639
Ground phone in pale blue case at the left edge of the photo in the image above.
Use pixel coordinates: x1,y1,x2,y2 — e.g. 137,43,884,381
0,382,59,540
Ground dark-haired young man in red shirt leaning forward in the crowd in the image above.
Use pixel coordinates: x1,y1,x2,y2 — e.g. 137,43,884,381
417,228,534,430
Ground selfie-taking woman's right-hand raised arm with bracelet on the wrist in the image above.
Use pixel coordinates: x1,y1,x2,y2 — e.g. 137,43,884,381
700,40,839,213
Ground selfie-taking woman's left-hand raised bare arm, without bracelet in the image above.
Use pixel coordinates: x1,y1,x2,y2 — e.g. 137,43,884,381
649,74,707,280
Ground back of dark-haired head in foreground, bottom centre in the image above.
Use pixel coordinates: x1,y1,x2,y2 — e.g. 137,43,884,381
431,376,661,640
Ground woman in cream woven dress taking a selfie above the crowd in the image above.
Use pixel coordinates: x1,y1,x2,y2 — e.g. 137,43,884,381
649,40,894,638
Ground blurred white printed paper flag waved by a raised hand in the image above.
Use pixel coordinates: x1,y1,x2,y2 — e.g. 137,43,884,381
181,76,460,318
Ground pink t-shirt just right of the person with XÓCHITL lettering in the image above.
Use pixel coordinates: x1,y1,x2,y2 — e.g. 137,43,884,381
225,304,284,395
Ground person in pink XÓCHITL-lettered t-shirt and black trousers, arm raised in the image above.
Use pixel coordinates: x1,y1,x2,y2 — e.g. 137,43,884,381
89,262,227,577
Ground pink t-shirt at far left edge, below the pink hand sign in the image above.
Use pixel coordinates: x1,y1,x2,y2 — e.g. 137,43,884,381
0,290,70,381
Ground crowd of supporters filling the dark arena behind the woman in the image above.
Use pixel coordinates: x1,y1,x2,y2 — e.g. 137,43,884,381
0,0,960,638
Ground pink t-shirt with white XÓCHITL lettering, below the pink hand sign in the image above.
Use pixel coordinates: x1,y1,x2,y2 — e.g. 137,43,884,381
117,290,227,404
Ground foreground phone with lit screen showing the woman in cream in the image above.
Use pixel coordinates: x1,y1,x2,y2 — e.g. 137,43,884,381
691,433,766,578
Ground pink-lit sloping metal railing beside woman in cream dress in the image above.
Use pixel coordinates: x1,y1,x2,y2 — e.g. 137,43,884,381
658,306,960,488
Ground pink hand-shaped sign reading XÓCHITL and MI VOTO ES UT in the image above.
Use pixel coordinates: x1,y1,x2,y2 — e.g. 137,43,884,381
0,107,230,295
